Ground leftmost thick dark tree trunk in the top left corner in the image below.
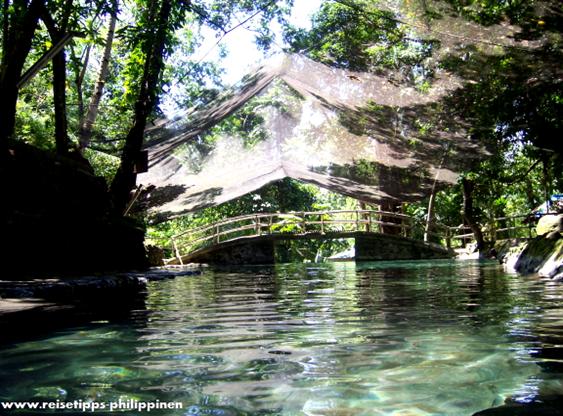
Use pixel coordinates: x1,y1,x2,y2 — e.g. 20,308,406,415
0,0,44,153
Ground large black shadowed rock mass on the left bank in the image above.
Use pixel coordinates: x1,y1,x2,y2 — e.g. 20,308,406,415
0,143,147,280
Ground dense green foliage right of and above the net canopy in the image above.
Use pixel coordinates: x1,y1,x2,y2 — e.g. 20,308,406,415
287,0,563,245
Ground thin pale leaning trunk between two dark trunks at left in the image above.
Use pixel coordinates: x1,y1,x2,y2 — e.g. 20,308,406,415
78,7,117,153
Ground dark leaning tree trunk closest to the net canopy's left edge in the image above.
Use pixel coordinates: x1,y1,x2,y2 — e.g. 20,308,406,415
110,0,171,215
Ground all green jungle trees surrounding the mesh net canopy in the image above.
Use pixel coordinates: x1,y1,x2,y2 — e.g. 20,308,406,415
0,0,563,260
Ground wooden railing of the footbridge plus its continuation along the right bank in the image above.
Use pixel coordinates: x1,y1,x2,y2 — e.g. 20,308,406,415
171,210,552,261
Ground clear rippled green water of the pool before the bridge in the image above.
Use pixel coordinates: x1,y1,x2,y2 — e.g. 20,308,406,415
0,261,563,416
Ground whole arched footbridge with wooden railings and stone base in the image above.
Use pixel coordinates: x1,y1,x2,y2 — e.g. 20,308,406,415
169,210,453,264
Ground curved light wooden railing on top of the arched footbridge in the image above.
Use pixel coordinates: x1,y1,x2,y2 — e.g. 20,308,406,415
171,210,450,259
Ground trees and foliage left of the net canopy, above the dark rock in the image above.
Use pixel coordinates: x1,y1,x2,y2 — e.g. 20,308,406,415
0,0,291,197
